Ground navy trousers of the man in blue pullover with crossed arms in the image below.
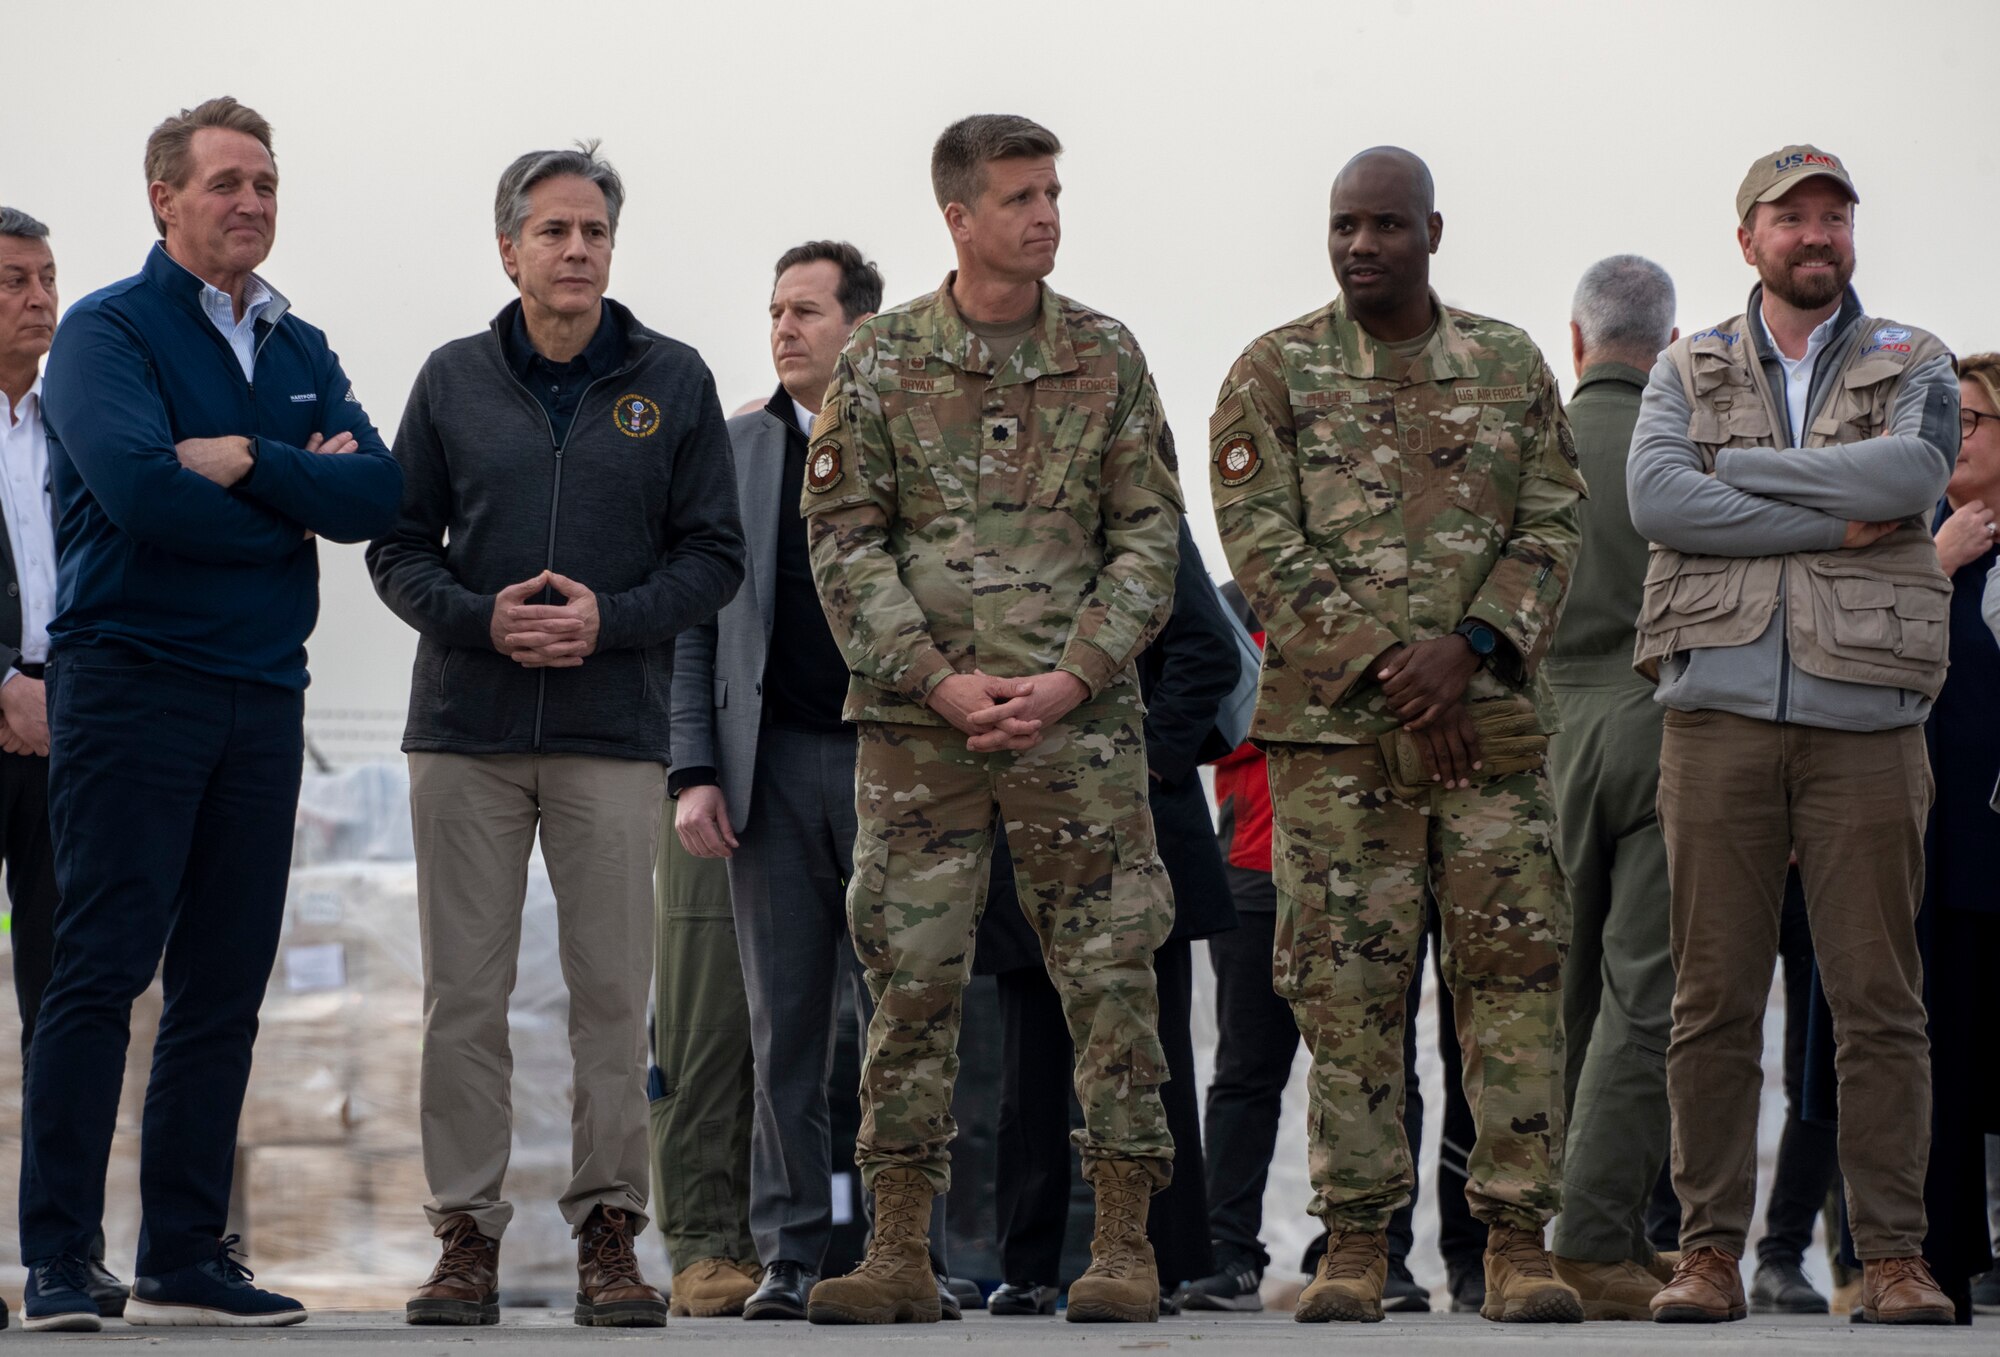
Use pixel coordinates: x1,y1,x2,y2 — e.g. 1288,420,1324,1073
20,646,304,1277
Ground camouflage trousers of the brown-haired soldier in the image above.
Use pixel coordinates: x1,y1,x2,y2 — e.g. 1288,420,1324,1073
848,707,1174,1191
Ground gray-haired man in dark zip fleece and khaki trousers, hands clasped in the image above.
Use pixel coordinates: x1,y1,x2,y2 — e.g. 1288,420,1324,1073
368,144,744,1325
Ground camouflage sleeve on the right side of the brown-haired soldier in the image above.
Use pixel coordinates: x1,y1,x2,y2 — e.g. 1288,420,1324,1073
1048,362,1180,697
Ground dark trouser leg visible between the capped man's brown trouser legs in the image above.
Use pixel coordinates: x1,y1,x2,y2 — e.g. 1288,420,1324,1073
1756,867,1840,1263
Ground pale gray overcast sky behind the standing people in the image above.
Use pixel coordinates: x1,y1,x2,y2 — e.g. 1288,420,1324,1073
0,0,2000,756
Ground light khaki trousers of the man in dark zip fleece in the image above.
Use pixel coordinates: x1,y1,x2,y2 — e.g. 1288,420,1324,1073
410,753,666,1239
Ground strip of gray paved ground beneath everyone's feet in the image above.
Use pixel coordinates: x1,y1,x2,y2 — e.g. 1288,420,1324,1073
0,1309,2000,1357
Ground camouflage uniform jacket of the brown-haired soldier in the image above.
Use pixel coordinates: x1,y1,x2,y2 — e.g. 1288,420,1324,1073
800,276,1180,725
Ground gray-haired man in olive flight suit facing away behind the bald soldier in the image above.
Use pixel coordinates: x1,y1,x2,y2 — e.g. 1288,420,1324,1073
1542,254,1680,1319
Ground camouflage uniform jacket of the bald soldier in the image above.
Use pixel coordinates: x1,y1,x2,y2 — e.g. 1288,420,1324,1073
1208,294,1584,745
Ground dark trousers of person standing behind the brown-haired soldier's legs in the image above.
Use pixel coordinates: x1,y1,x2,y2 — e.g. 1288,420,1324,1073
994,935,1208,1291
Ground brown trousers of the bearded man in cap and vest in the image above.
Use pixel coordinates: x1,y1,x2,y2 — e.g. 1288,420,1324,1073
1660,711,1932,1259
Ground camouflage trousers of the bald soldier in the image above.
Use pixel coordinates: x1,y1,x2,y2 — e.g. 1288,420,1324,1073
1268,745,1570,1231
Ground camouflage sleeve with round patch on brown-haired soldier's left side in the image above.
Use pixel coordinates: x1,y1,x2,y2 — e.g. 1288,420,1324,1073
800,340,956,705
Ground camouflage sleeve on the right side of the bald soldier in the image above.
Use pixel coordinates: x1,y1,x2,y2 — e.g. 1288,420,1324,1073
1466,364,1584,685
